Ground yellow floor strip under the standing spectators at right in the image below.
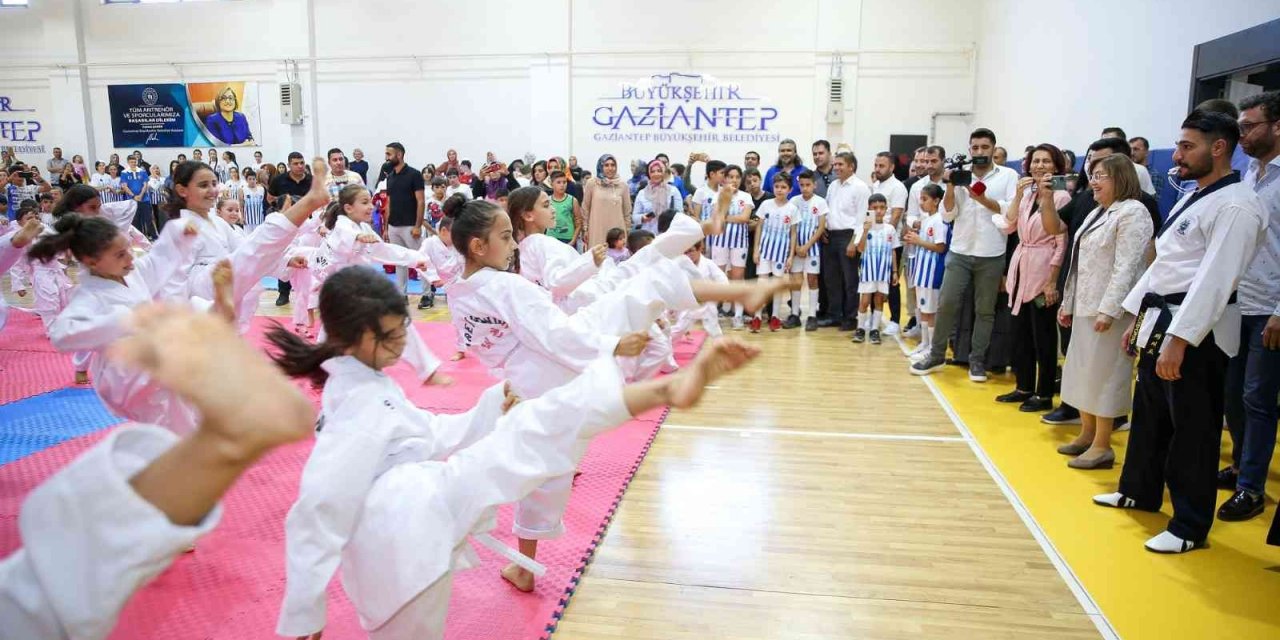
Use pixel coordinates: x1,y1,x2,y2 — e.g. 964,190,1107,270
921,337,1280,640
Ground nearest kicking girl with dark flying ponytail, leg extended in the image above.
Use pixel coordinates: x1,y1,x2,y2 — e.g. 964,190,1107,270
269,264,758,640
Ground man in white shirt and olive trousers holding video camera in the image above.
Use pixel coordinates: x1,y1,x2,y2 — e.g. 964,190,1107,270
911,129,1018,383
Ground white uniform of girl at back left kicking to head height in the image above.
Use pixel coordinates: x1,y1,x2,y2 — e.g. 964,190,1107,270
164,209,298,333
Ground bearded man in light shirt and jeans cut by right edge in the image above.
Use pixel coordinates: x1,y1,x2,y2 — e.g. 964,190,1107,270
1217,91,1280,524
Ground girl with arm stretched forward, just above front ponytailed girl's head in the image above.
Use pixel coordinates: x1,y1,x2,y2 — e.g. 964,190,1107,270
310,184,453,385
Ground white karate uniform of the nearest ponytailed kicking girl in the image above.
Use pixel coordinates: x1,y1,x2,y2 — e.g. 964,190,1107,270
276,356,640,640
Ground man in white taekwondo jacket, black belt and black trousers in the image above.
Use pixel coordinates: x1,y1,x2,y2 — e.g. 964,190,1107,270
1093,110,1266,553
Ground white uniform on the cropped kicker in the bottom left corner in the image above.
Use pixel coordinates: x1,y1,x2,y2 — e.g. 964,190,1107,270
0,424,221,640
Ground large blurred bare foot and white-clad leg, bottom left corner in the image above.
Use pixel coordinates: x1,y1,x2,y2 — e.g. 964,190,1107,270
0,300,315,640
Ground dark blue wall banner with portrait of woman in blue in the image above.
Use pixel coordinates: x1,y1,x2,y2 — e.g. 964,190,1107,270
106,81,262,148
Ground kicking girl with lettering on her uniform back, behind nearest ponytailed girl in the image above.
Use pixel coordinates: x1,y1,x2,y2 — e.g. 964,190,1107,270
445,200,785,591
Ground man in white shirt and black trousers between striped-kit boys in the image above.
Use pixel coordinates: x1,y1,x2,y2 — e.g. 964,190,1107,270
822,151,872,332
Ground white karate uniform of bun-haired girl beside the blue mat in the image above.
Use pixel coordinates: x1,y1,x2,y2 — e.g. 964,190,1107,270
49,224,207,434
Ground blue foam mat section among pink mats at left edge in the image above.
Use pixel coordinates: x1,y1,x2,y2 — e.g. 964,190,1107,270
0,389,124,465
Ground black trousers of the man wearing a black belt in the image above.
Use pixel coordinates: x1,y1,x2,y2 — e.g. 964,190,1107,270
1120,333,1228,543
